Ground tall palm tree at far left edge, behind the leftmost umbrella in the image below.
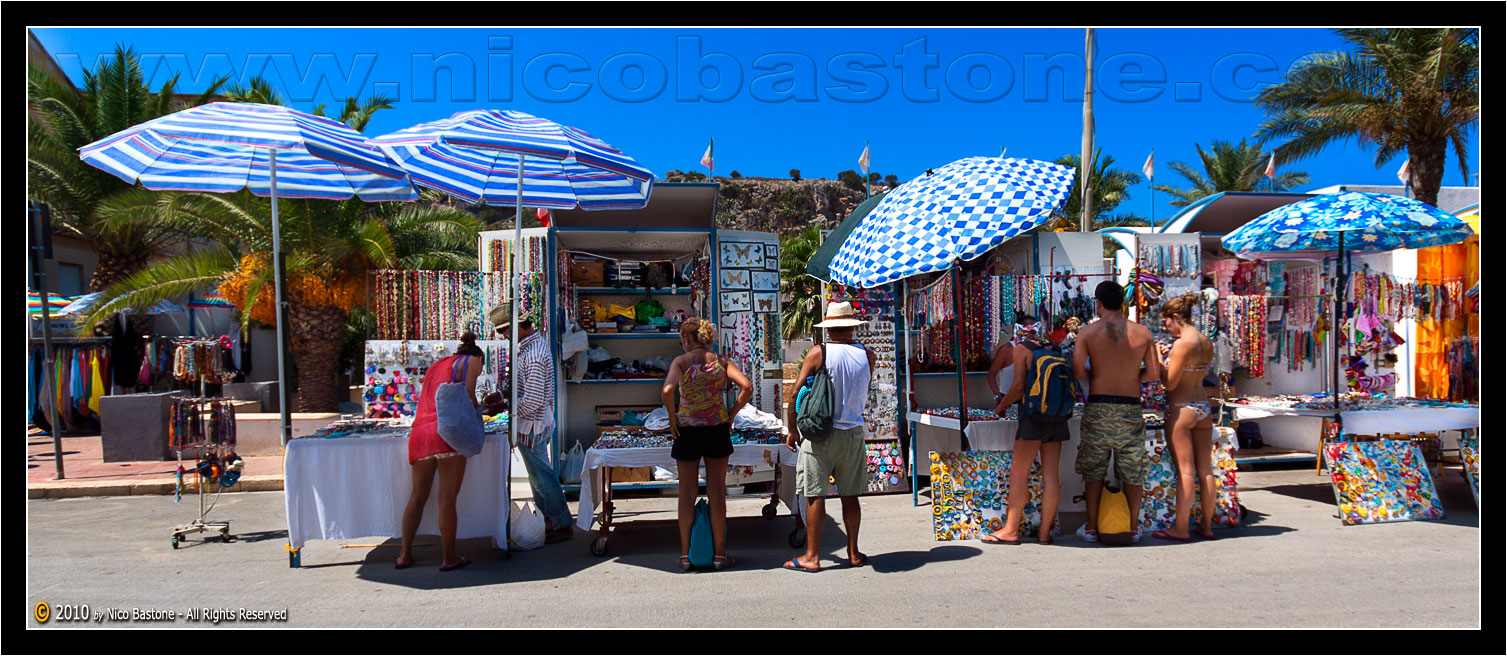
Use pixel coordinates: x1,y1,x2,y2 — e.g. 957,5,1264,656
27,45,228,293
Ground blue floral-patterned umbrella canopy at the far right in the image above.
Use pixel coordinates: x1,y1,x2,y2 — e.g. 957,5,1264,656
1219,192,1471,259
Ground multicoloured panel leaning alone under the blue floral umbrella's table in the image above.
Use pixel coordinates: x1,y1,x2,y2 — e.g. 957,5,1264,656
1325,440,1444,526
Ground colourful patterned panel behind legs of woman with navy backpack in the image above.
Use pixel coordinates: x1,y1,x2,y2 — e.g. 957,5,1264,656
930,451,1058,541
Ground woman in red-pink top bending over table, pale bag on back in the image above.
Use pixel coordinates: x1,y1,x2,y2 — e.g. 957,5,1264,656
395,333,487,572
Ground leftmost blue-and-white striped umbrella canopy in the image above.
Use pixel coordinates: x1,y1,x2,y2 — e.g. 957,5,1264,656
78,103,419,202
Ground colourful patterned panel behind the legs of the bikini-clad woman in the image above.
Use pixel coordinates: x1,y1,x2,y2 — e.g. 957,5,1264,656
1139,428,1240,534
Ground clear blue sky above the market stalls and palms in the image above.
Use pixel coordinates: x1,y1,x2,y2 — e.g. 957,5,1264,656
33,29,1478,219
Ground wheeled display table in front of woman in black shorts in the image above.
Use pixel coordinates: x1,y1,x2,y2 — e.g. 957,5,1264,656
576,427,805,556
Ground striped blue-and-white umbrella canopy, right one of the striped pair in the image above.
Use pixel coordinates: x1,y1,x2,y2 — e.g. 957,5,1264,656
372,110,654,210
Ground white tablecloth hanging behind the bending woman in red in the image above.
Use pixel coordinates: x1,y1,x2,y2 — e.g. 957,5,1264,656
283,434,511,549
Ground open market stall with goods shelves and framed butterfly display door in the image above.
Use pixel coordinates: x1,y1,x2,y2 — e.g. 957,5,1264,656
479,184,791,553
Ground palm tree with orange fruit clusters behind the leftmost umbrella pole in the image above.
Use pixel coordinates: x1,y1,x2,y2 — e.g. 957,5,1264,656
84,190,481,412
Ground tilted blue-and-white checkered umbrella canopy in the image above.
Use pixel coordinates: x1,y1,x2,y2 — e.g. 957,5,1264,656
830,157,1073,288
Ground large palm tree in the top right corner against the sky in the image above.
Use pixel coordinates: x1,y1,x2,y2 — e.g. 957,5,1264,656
1255,27,1481,205
